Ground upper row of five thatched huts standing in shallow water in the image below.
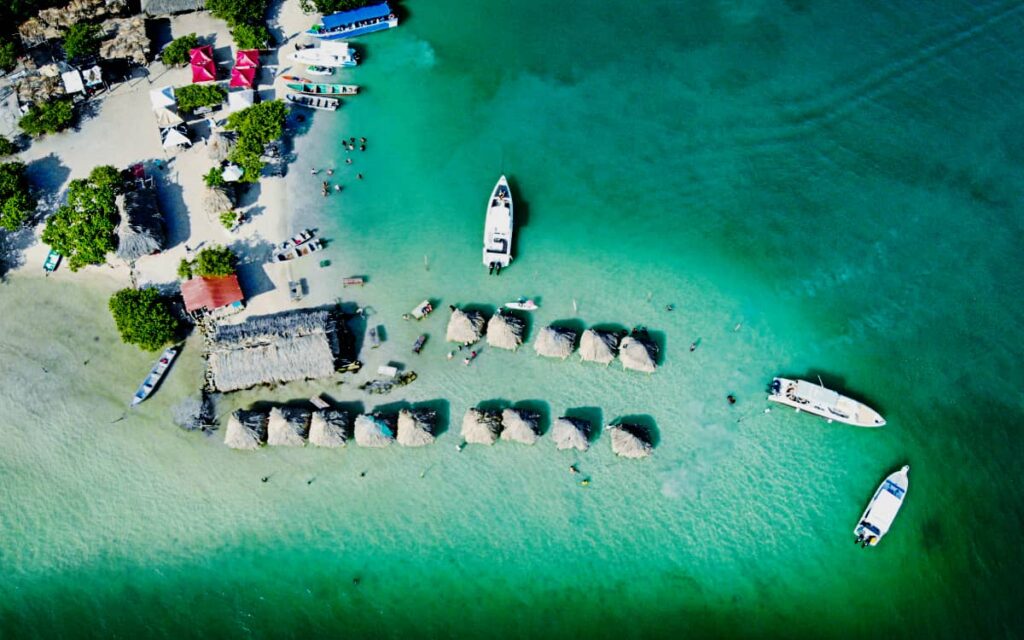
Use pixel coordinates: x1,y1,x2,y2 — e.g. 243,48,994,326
446,307,657,373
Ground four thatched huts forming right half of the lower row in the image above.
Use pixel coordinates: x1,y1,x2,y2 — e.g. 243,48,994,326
462,409,653,459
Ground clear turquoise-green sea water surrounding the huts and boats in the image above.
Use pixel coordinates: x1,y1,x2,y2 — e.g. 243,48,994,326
0,0,1024,637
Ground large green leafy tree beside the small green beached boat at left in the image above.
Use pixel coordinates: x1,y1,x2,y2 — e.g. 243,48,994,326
43,166,124,271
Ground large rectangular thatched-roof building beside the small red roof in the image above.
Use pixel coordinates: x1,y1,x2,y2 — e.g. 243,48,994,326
206,309,345,391
